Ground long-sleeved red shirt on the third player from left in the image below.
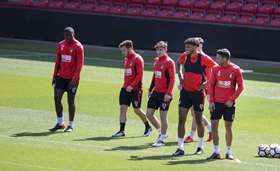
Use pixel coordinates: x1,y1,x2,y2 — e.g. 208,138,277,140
149,55,176,96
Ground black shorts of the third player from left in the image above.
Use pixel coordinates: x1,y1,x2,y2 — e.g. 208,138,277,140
148,92,172,111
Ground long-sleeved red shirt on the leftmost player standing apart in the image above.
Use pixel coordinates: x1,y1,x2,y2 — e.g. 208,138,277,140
53,39,84,81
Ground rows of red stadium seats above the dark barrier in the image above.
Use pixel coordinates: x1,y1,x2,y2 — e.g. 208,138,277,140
0,0,280,28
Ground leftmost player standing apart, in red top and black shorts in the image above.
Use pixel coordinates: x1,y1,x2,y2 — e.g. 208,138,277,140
50,27,84,132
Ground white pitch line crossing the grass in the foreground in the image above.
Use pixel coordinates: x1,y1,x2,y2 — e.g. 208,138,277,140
0,135,280,169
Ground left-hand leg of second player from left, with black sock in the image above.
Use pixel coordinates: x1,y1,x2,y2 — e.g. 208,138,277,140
112,88,130,137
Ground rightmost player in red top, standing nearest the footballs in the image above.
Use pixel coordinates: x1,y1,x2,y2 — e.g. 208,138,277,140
208,49,244,160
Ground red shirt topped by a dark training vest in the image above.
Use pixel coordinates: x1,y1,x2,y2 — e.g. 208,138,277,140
178,52,217,92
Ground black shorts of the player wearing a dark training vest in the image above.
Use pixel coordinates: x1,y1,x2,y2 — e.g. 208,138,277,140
179,90,204,112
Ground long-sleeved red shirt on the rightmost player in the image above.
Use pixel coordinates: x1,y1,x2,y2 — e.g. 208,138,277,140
209,63,244,103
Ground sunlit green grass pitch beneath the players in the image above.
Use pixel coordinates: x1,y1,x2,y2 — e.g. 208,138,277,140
0,39,280,171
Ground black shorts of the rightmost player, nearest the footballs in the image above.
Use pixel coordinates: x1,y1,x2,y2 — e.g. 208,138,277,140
211,102,235,122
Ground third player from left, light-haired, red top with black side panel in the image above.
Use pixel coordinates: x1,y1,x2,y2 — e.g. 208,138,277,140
146,41,176,147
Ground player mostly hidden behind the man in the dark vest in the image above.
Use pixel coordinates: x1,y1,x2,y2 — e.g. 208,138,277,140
185,37,212,143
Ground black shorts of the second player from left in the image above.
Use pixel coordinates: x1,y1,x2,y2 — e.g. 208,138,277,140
119,88,142,108
